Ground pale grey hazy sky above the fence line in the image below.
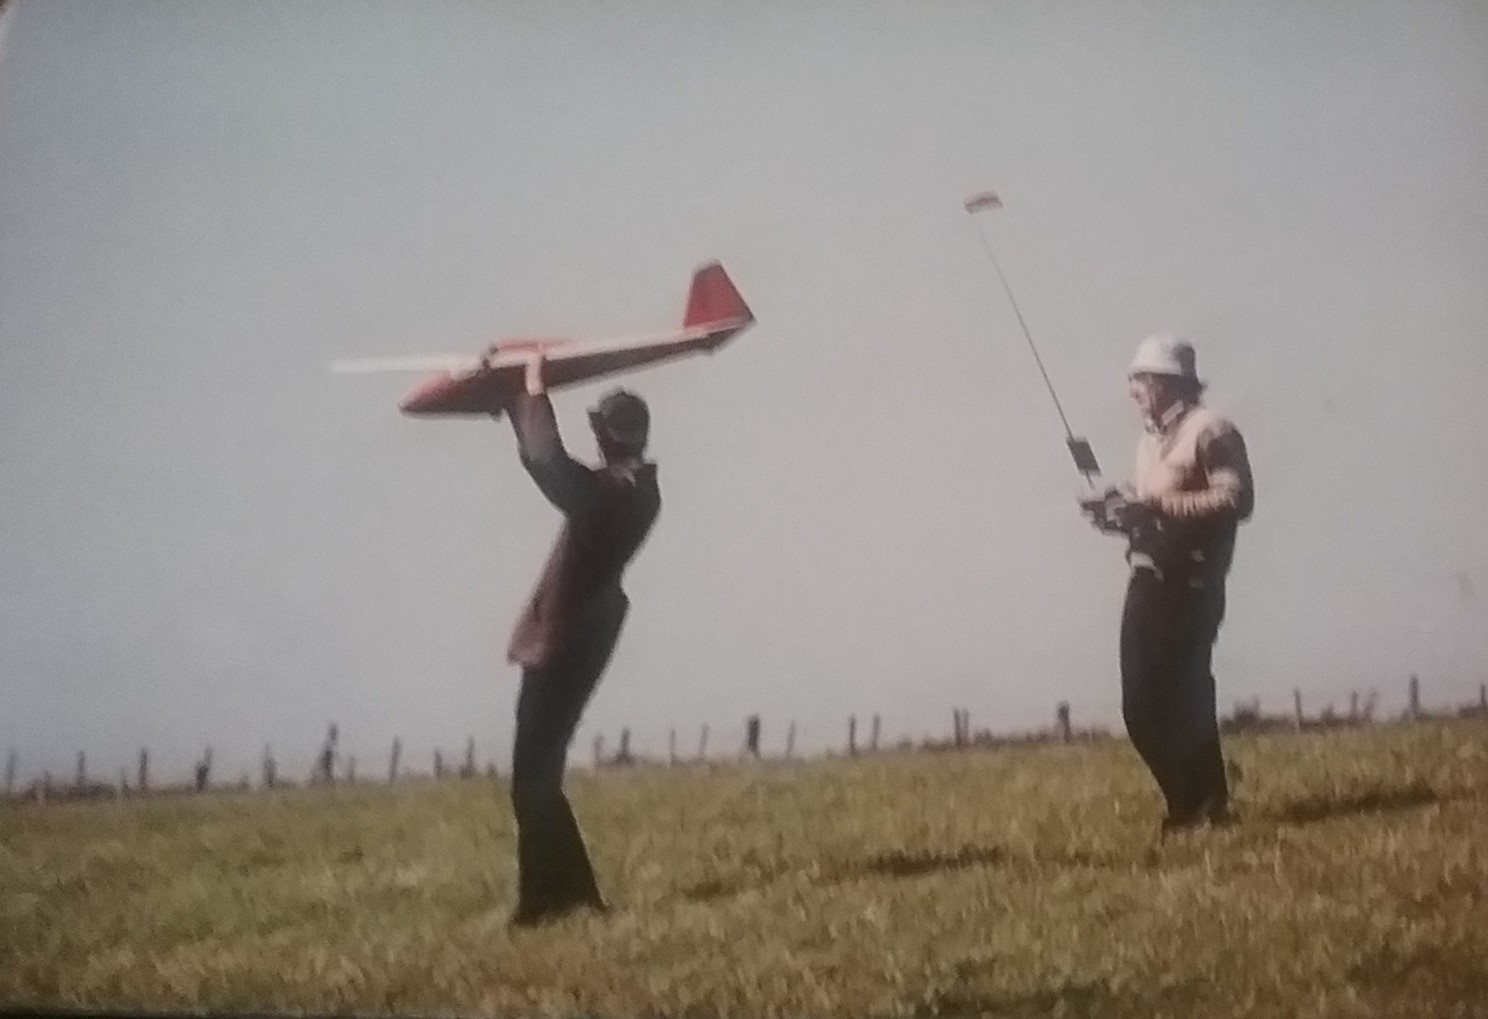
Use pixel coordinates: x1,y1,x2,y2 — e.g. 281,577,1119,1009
0,0,1488,779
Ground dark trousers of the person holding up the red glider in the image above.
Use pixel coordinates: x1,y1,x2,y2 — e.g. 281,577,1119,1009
512,604,625,921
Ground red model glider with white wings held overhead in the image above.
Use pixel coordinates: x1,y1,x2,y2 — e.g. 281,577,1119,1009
330,262,754,417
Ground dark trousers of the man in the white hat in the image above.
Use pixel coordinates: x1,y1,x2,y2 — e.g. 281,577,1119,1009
1120,570,1229,824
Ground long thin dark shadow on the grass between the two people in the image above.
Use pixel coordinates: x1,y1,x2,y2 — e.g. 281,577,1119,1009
682,845,1120,901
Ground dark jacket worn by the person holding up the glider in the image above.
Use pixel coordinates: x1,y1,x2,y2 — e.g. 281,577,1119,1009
506,393,661,668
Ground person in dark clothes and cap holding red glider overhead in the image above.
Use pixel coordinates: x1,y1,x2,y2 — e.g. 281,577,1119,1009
497,356,661,925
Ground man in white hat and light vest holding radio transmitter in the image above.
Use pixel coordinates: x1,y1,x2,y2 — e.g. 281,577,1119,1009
1082,335,1254,832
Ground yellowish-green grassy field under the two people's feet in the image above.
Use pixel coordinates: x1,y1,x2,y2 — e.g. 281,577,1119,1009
0,721,1488,1018
